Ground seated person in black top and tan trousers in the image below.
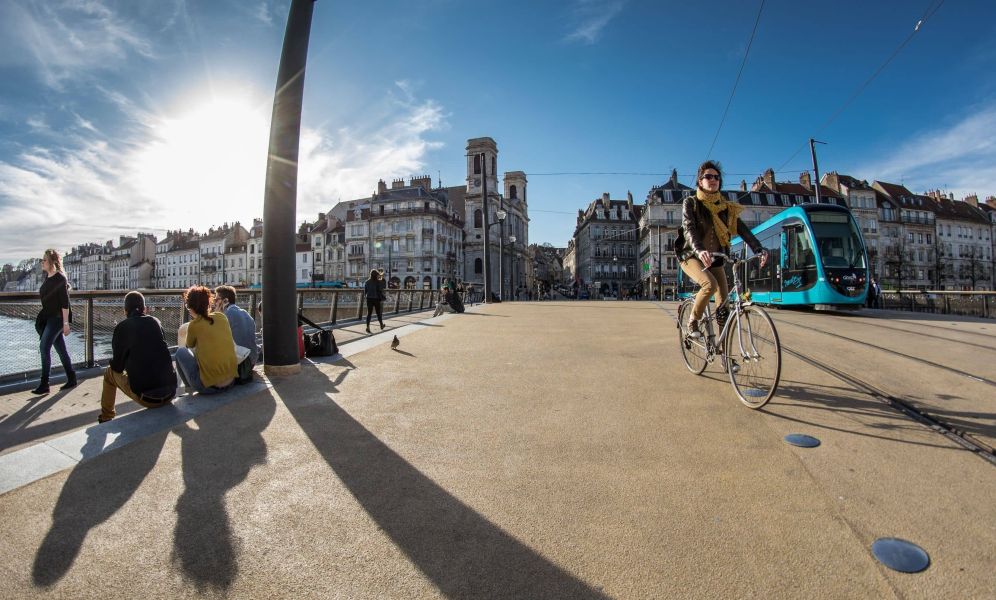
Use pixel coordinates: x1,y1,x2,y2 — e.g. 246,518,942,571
97,292,176,423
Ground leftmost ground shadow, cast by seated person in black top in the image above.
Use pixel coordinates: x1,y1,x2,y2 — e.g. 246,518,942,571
31,421,169,588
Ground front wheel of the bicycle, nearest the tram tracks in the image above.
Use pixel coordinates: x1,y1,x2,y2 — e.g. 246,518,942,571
726,305,782,409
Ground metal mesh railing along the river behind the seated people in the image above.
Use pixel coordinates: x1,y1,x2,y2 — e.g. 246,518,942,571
0,288,452,383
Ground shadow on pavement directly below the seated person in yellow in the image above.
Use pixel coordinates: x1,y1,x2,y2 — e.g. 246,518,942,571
171,391,276,593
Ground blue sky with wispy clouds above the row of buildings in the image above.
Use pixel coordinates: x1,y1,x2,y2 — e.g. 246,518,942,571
0,0,996,261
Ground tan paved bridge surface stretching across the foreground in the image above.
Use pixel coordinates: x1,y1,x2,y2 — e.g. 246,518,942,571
0,302,996,599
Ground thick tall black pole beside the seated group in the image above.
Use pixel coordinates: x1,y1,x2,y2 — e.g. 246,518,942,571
263,0,314,375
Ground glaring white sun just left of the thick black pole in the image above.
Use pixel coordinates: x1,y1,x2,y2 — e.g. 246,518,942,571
132,98,269,228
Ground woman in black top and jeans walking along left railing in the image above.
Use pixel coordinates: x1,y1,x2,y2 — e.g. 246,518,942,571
31,248,76,394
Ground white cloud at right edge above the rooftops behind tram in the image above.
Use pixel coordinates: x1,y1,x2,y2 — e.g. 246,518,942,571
862,106,996,198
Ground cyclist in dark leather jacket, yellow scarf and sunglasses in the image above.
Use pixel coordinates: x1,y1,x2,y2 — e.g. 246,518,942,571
675,160,768,337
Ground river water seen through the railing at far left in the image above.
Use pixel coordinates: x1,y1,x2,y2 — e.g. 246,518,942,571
0,315,111,376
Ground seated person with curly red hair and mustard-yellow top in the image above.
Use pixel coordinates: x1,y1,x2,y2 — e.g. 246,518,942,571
176,285,239,394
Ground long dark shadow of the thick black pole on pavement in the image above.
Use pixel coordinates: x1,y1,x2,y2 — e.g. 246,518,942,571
275,361,607,598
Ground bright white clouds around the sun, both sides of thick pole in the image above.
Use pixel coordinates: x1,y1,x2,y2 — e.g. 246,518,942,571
0,86,446,258
